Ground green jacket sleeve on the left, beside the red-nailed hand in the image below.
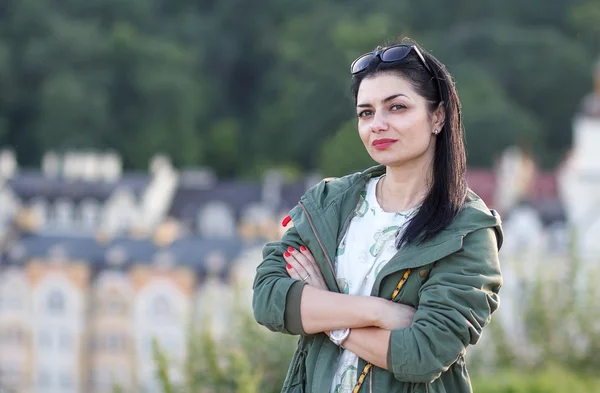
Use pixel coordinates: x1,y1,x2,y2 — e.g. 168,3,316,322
252,227,306,335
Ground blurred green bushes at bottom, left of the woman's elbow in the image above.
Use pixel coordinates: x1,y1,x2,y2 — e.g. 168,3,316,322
154,288,297,393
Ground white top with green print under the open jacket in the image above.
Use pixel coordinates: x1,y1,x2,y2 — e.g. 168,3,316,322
331,177,417,393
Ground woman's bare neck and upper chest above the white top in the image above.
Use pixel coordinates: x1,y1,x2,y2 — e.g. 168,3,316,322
378,162,432,212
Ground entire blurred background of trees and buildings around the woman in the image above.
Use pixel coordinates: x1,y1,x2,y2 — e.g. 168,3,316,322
0,0,600,393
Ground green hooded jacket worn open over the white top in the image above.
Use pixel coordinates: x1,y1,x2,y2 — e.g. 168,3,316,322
253,166,503,393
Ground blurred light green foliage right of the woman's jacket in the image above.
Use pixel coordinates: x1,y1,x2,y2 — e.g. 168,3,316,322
469,242,600,376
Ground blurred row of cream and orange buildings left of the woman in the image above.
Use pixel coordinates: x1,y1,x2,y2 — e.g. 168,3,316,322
0,150,317,393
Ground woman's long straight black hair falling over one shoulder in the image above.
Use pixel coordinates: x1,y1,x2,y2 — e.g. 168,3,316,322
352,39,467,247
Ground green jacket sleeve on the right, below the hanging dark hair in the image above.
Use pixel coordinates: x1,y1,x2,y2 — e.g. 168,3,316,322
387,228,502,383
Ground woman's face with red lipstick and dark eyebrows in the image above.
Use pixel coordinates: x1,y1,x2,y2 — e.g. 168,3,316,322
356,73,443,167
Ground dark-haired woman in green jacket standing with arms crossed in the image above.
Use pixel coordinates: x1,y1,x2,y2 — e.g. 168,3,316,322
253,39,502,393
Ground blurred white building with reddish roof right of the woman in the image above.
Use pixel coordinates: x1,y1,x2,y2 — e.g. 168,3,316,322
476,56,600,359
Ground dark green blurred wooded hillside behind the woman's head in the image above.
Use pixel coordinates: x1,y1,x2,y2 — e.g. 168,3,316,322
0,0,600,176
